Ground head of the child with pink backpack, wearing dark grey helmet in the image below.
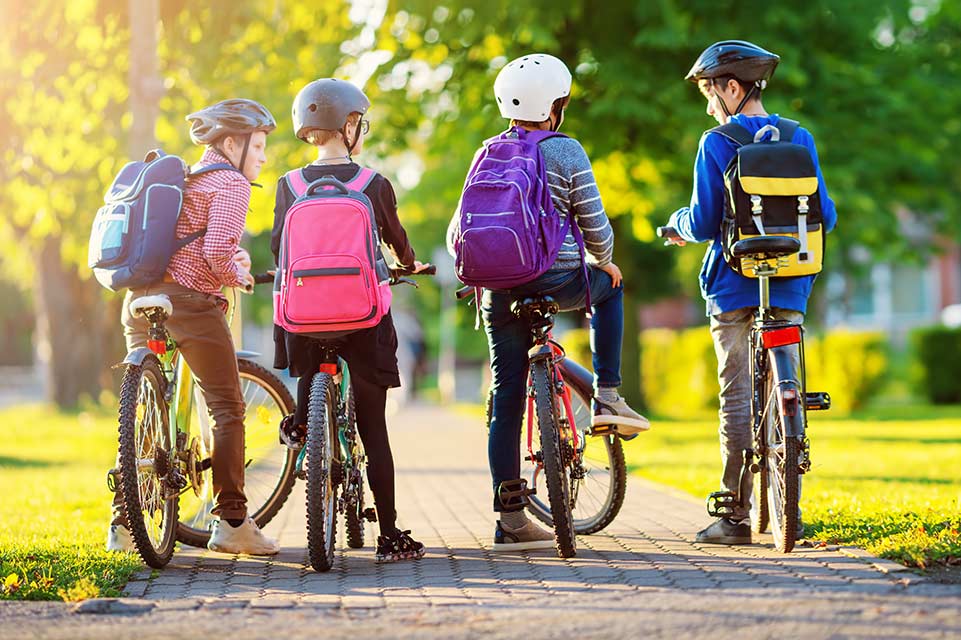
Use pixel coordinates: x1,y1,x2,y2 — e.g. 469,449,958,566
291,78,370,156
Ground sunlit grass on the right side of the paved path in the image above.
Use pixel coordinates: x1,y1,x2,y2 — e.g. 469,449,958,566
626,406,961,568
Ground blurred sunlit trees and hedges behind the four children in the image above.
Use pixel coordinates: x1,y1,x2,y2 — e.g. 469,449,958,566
0,0,961,414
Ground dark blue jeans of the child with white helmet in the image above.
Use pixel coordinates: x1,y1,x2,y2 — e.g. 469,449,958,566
481,267,624,511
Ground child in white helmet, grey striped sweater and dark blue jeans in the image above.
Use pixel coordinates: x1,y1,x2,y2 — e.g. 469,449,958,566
447,54,650,551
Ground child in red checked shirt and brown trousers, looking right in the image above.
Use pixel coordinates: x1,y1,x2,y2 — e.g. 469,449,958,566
107,99,280,555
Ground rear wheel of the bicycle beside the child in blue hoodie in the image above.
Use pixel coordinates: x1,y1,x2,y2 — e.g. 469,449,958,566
762,363,801,553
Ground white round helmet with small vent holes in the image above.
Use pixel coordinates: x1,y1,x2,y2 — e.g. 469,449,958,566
494,53,571,122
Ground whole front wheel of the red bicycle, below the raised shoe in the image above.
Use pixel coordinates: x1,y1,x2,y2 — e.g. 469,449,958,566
527,385,627,535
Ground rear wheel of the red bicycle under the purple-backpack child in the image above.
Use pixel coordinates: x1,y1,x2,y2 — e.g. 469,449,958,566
531,360,577,558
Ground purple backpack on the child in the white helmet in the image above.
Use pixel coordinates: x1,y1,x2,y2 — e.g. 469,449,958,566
453,127,584,289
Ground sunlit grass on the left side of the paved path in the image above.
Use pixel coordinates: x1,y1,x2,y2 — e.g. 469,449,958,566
0,406,143,600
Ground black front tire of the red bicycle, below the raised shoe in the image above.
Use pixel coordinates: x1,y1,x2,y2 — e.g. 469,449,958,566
527,385,627,535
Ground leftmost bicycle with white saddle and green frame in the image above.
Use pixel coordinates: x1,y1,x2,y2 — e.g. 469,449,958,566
107,274,295,569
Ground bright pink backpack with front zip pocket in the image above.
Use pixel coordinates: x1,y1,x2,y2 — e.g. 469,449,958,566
274,167,391,339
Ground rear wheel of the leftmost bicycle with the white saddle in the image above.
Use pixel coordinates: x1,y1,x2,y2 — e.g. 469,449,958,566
118,355,179,569
